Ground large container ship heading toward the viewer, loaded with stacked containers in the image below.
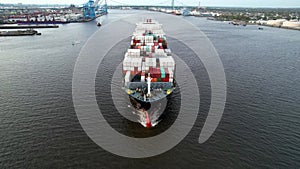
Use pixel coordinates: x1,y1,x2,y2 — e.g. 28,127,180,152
123,19,176,128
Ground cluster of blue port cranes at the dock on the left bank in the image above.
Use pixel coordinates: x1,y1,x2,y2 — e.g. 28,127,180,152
83,0,107,20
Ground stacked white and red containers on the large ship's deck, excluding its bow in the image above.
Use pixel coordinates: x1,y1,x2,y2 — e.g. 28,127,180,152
123,19,175,84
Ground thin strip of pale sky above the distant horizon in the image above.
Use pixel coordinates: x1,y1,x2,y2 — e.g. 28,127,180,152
0,0,300,7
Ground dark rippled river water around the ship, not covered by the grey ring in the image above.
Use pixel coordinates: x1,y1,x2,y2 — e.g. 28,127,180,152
0,10,300,168
